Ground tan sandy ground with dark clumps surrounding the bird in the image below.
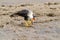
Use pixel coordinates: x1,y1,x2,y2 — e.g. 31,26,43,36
0,3,60,40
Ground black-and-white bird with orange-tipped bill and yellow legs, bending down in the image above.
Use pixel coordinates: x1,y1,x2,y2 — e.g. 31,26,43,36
11,9,35,27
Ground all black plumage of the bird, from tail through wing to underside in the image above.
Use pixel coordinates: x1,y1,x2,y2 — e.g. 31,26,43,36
10,9,29,20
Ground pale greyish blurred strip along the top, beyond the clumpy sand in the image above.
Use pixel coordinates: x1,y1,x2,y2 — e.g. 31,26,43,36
0,0,60,5
